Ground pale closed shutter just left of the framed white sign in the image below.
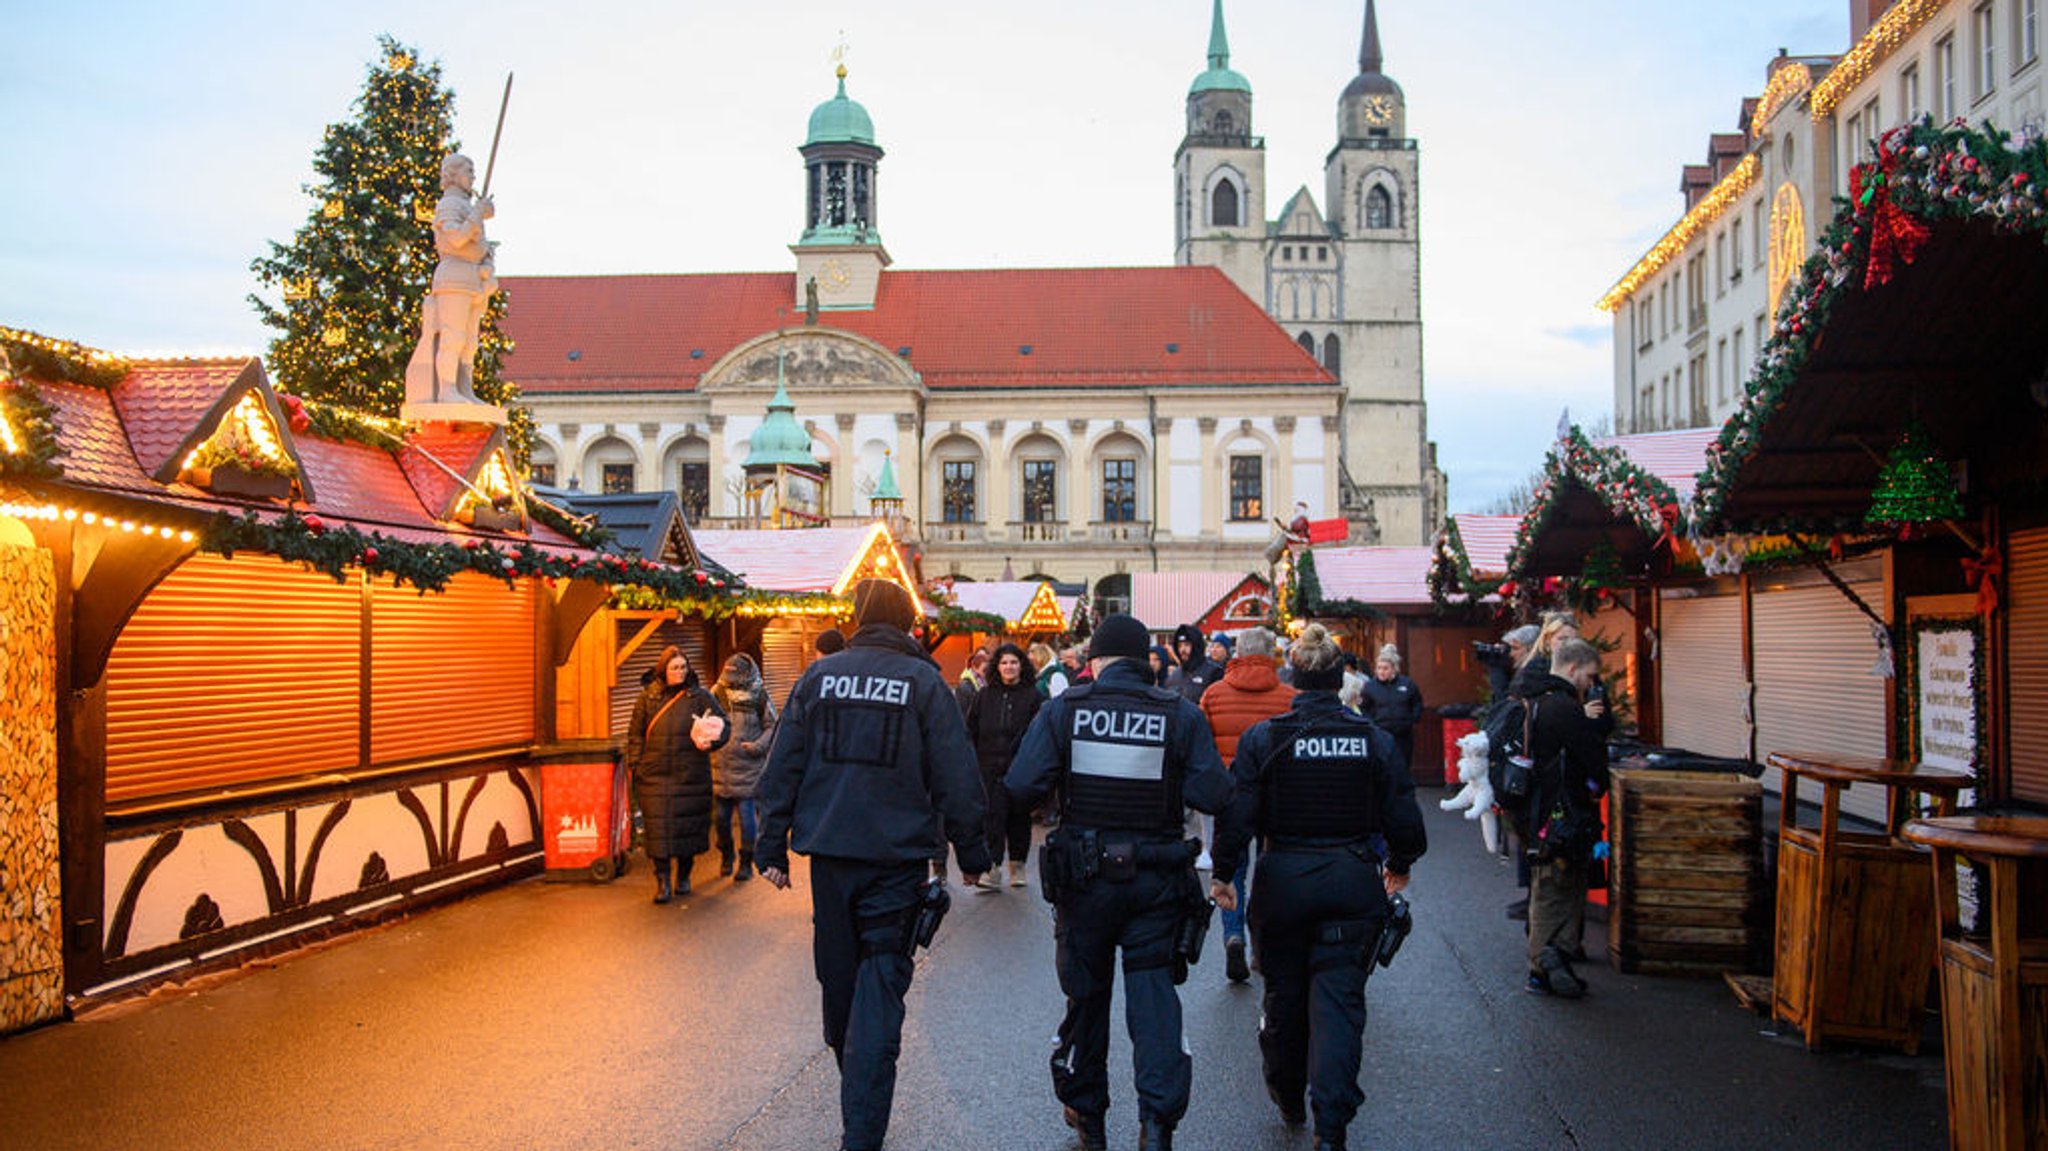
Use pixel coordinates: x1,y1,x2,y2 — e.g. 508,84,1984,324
1751,565,1892,823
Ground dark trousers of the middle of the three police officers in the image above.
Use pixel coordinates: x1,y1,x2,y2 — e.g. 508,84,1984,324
1053,864,1194,1126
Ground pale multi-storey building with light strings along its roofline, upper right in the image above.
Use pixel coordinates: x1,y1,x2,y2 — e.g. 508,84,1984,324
1599,0,2044,432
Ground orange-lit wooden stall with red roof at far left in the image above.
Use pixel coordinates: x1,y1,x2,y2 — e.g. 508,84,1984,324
0,332,745,1026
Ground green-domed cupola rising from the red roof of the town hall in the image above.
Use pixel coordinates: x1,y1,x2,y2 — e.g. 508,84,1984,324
791,63,889,309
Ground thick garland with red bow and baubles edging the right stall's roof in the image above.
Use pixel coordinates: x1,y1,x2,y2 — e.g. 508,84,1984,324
1694,117,2048,532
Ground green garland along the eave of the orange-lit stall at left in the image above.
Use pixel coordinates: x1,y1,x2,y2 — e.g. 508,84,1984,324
199,501,745,619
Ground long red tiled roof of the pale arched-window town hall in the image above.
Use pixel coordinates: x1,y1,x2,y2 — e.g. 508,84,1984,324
504,266,1335,395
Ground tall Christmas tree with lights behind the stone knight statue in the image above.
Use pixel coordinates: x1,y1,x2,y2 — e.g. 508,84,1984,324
250,37,532,461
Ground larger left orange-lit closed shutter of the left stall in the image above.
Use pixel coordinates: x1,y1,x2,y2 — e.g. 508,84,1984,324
106,555,362,805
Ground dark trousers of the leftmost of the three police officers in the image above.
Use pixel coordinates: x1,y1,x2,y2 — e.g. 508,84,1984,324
811,856,926,1151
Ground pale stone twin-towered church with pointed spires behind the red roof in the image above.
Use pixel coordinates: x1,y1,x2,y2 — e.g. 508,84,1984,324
1174,0,1446,545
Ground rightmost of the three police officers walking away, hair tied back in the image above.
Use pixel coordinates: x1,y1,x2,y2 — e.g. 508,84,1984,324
1210,625,1427,1151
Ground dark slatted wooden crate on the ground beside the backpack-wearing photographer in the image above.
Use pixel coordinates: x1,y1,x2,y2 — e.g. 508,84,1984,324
1608,770,1769,975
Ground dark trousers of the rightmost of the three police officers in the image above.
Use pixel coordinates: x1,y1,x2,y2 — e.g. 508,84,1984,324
1249,846,1389,1137
